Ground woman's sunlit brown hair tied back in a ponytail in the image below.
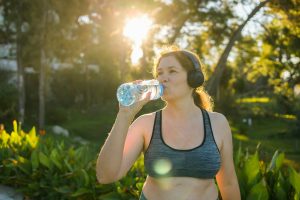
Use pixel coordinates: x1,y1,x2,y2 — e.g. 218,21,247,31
153,46,214,111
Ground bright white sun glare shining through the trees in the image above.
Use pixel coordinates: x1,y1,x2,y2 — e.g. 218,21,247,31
123,15,153,64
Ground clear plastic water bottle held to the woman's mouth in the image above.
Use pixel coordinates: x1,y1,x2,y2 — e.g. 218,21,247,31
117,79,163,106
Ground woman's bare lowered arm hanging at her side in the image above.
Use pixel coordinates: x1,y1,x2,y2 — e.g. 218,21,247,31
216,115,241,200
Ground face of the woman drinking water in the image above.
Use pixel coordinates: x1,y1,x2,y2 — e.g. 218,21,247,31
157,55,192,101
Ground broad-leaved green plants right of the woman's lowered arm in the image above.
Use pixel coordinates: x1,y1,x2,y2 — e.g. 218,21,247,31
235,147,300,200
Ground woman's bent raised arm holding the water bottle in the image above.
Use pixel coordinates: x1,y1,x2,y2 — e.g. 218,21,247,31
96,95,149,184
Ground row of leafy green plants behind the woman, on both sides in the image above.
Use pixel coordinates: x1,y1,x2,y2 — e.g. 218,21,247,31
0,121,300,200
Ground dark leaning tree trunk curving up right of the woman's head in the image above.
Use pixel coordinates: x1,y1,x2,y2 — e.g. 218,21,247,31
206,0,270,98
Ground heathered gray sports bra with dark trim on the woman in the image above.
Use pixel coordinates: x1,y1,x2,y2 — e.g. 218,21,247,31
144,109,221,179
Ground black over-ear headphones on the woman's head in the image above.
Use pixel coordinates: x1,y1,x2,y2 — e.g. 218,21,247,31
182,50,204,88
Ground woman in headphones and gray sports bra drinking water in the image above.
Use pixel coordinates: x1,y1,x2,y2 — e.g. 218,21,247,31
96,49,240,200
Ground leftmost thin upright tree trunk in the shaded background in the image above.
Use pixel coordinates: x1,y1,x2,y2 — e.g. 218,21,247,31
16,3,26,123
